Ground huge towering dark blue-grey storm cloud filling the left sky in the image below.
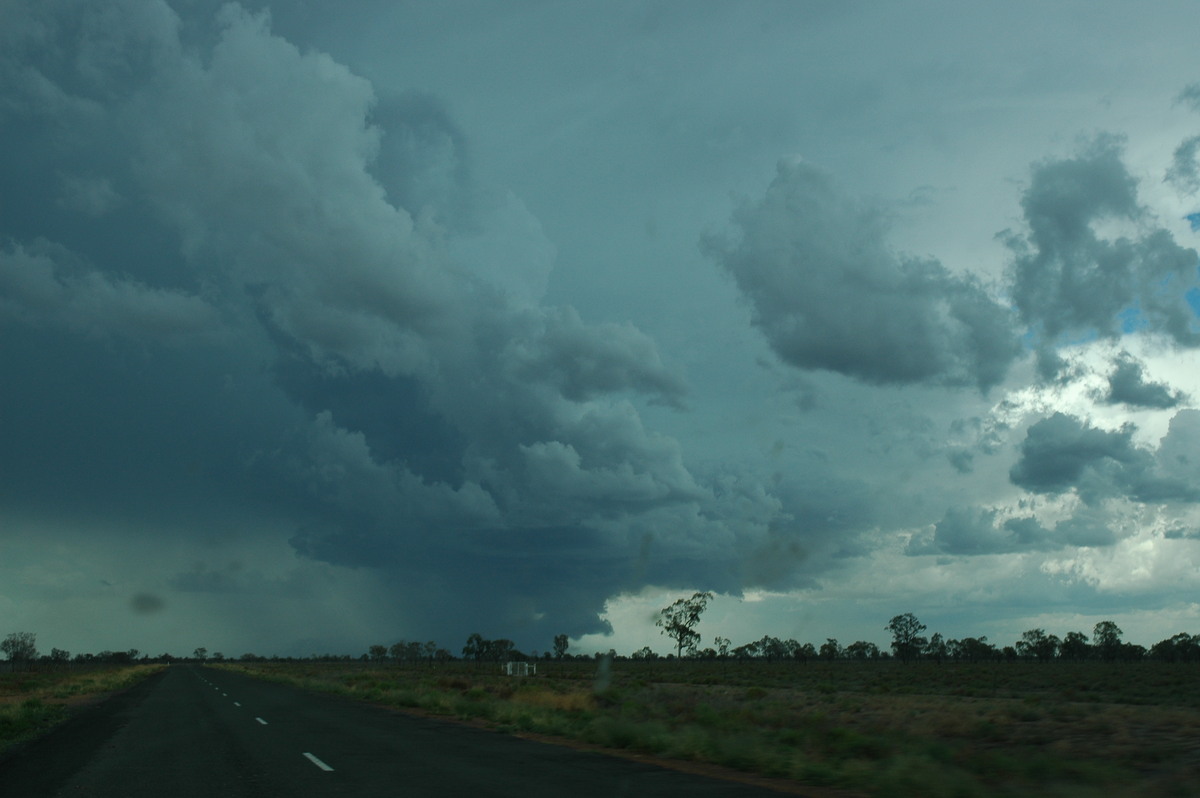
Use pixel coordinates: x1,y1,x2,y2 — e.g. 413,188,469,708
0,2,777,636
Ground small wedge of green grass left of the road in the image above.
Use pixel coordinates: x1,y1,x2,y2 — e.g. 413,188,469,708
0,664,164,754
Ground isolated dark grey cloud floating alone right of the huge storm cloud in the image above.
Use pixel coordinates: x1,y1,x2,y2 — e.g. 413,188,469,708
706,158,1020,390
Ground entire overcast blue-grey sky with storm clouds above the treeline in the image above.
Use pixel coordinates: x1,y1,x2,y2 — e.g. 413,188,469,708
0,0,1200,656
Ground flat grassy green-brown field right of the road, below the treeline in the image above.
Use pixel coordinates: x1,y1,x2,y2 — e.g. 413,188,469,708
223,660,1200,797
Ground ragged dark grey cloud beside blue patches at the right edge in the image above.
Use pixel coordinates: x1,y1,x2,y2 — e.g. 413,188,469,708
1001,137,1200,352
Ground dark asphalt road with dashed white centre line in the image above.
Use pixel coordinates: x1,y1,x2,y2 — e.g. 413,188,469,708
0,666,796,798
